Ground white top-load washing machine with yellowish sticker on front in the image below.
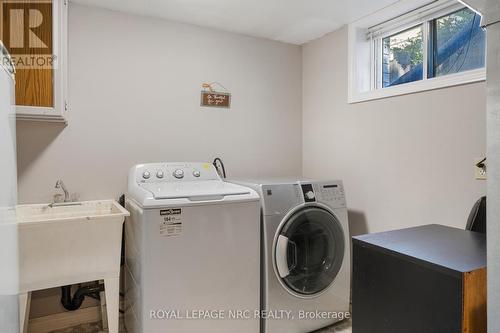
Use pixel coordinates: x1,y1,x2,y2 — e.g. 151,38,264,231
125,163,260,333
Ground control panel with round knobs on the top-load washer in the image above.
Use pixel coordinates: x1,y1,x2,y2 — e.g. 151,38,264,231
133,163,221,184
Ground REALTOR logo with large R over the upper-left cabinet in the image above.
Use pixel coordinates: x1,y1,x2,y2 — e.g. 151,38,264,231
0,0,55,69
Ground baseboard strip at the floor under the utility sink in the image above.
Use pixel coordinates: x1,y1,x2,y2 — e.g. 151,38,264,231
28,306,101,333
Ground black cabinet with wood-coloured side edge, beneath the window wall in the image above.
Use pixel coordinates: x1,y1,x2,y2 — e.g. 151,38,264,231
352,225,486,333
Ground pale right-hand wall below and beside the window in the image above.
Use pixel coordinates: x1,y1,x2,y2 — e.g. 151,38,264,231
303,28,486,233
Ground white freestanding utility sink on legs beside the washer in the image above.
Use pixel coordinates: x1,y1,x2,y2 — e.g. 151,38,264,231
16,200,130,332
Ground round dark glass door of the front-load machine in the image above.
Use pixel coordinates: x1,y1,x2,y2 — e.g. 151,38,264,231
275,207,345,296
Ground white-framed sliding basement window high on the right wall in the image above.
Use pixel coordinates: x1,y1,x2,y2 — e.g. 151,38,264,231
349,1,486,103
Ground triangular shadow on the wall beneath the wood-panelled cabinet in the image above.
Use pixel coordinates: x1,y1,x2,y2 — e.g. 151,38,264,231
17,121,66,178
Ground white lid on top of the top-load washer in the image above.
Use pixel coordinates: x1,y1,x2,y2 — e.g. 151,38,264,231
141,180,250,201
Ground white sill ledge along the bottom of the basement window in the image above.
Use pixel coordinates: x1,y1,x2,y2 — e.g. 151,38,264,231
348,68,486,104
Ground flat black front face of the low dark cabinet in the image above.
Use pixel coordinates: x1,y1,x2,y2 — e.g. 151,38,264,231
352,240,462,333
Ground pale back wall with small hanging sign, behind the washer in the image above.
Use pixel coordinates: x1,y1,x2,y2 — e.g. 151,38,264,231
18,4,302,203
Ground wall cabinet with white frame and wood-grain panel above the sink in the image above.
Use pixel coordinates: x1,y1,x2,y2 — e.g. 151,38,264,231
0,0,68,123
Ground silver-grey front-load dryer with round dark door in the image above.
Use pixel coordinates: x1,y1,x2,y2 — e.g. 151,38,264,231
233,181,351,333
